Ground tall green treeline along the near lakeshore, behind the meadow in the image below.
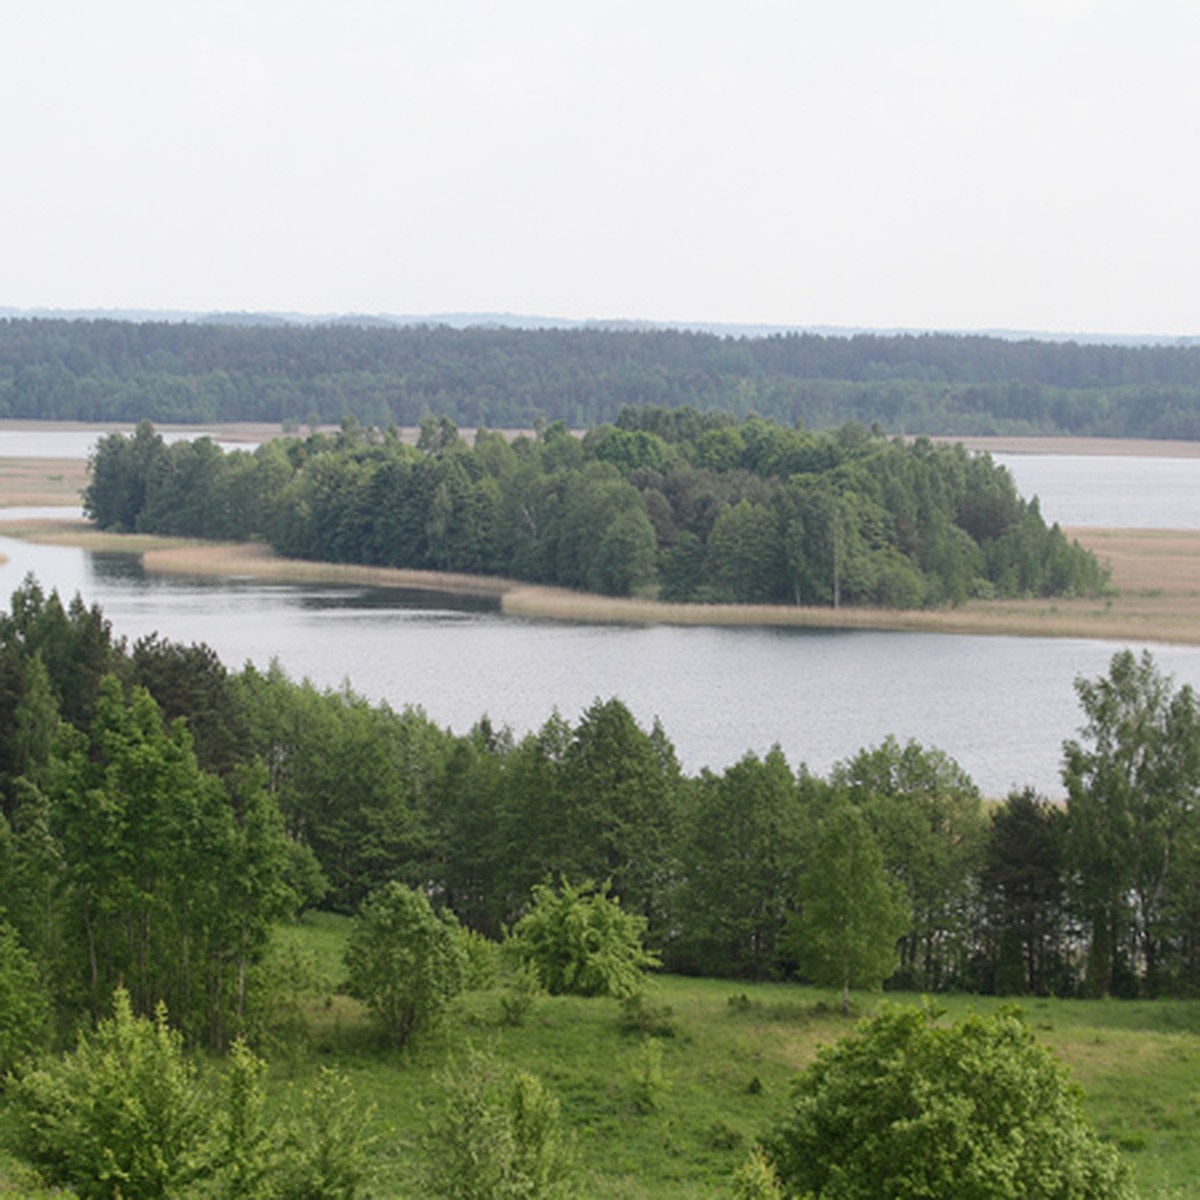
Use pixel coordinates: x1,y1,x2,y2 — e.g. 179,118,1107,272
0,581,1200,1043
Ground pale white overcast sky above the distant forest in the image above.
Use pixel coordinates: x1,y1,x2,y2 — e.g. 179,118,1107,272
0,0,1200,335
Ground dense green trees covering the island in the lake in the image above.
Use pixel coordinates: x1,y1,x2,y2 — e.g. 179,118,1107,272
84,408,1104,608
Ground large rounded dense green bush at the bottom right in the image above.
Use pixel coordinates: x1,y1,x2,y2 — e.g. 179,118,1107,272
767,1007,1133,1200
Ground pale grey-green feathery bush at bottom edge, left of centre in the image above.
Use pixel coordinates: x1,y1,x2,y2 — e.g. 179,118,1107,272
422,1052,574,1200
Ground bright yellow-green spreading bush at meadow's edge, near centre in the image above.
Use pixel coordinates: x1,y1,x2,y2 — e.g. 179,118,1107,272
509,880,659,997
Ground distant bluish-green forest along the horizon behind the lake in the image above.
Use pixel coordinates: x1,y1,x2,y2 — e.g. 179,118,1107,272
7,319,1200,438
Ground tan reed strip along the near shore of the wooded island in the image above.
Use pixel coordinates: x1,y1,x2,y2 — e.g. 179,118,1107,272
7,510,1200,644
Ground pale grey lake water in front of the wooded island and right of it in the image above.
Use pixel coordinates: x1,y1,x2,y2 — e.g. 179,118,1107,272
0,443,1200,797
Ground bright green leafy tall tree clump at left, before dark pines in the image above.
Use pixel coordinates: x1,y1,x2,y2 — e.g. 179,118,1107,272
47,677,295,1046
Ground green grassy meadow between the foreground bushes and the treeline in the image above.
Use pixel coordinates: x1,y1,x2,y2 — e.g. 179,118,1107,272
0,914,1200,1200
